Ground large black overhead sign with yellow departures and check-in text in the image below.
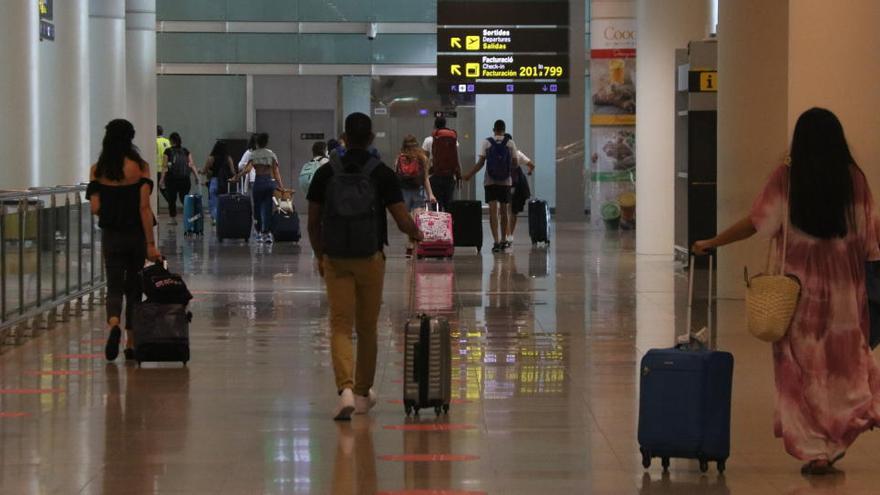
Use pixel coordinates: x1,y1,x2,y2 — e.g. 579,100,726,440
437,0,569,94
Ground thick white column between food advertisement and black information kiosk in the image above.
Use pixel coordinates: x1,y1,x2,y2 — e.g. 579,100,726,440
636,0,708,256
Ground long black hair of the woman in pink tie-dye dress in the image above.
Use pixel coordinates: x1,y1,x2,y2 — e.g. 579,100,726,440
790,108,856,239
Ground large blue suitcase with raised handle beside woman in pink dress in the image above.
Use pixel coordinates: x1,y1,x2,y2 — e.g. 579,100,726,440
638,257,733,473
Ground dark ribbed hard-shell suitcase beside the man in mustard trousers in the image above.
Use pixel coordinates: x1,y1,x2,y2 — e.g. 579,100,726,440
403,314,452,416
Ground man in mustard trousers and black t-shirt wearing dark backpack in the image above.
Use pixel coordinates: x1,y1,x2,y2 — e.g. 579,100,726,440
307,113,422,420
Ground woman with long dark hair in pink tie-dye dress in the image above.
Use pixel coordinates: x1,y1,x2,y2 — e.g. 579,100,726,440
694,108,880,474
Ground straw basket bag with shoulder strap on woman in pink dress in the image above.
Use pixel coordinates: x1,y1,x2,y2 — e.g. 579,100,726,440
745,176,801,342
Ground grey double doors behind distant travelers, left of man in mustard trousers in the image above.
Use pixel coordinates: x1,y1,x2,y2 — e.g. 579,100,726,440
257,110,334,213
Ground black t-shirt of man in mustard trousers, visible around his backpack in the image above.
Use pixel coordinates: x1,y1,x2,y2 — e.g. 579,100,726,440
306,149,403,251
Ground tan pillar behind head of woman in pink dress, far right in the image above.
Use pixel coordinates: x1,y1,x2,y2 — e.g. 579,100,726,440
788,0,880,186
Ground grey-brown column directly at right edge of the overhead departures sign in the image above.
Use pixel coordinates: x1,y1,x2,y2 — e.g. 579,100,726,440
555,0,587,222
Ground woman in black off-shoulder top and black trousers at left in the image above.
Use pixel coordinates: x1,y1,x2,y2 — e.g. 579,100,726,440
86,119,162,361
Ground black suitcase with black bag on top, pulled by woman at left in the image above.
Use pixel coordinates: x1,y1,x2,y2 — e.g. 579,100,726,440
132,260,192,366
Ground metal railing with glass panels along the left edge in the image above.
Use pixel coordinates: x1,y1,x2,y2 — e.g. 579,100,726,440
0,185,107,345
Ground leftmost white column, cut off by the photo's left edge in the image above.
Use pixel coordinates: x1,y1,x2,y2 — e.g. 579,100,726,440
0,0,40,189
